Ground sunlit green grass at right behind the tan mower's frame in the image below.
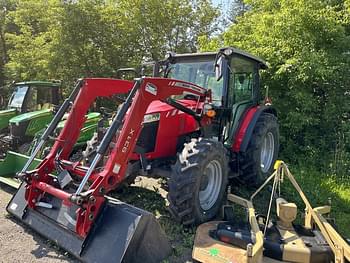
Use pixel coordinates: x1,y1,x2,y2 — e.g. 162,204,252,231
232,167,350,239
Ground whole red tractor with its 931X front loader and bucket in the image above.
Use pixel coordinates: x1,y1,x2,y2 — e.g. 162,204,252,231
7,48,279,262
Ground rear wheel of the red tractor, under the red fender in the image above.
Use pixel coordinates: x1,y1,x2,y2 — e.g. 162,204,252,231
239,113,279,186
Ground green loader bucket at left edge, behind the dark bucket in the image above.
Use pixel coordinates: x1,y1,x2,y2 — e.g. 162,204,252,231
0,151,41,188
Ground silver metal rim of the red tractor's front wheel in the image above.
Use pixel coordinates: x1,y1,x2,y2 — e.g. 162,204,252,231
199,160,222,210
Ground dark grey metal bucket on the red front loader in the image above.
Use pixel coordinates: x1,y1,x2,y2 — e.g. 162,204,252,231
7,183,171,262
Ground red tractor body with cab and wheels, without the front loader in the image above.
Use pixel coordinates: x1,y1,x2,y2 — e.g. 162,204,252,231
126,48,279,225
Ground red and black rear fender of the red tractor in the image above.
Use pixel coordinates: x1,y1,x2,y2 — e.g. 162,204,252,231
232,106,277,153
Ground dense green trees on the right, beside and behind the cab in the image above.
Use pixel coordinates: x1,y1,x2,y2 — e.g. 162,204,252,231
201,0,350,171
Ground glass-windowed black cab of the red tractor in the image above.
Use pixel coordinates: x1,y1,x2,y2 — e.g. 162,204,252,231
164,48,267,145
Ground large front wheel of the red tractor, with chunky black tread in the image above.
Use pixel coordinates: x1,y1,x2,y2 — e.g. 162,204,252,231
168,138,228,225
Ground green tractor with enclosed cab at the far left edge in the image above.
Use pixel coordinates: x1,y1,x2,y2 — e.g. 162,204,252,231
0,81,61,155
